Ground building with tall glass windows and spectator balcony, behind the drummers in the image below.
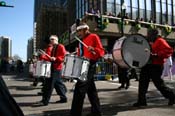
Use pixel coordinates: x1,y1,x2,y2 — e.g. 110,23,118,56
68,0,175,52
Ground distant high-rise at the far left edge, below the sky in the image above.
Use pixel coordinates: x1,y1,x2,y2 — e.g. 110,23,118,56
0,36,12,59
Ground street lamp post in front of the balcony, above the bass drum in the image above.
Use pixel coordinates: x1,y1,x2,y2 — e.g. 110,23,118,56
121,0,127,36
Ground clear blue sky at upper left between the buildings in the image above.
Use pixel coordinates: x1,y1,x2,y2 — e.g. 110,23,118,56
0,0,34,61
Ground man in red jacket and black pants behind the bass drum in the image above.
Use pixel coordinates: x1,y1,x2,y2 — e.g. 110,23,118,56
133,29,175,107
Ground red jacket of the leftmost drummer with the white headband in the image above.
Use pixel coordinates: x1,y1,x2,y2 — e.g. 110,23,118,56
40,44,66,70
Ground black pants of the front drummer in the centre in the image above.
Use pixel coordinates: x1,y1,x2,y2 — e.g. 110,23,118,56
71,64,101,116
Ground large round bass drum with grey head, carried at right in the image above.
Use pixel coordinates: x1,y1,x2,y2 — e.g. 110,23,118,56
112,34,151,68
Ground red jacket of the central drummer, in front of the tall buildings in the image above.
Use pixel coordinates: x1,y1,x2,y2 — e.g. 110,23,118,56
78,34,105,61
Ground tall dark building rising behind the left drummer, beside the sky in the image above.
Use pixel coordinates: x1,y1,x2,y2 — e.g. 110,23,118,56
34,0,69,52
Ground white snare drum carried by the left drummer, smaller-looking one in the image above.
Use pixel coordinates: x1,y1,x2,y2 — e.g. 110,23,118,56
35,61,51,78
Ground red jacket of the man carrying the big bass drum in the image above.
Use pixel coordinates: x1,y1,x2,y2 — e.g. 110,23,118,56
151,37,173,65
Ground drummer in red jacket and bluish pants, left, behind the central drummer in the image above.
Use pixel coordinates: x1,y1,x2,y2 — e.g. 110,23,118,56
39,35,67,105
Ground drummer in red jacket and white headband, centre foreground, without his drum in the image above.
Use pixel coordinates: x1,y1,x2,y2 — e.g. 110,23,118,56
70,23,104,116
